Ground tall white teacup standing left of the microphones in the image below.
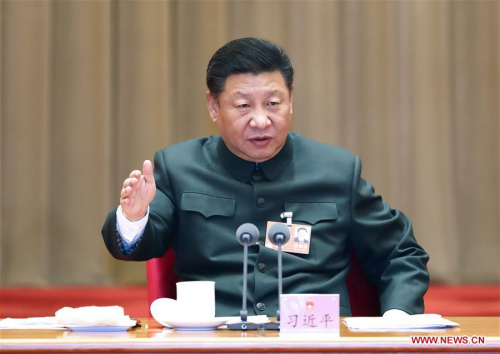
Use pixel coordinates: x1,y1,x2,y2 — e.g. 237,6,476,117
177,281,215,319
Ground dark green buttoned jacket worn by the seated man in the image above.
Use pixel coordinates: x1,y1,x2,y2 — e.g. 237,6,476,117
102,133,429,316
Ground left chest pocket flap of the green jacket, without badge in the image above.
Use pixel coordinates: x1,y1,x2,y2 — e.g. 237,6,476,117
181,192,236,218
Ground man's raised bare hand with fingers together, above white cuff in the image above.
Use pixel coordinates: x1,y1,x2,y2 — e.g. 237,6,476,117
120,160,156,221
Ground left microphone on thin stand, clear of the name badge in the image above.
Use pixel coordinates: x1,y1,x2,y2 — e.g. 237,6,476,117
227,223,259,330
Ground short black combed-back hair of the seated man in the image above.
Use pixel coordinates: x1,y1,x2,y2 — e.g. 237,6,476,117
207,38,293,99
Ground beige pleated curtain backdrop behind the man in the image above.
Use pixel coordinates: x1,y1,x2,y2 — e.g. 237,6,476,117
0,0,500,286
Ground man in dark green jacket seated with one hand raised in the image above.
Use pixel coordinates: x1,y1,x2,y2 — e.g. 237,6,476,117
102,38,429,316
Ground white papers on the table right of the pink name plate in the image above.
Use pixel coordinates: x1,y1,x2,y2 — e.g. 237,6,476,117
344,314,459,331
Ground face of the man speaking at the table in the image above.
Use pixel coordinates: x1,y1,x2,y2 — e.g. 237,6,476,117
207,71,292,162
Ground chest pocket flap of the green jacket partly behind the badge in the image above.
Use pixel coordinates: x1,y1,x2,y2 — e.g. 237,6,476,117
285,202,338,225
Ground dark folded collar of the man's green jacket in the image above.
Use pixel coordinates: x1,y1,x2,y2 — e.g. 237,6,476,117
217,135,293,183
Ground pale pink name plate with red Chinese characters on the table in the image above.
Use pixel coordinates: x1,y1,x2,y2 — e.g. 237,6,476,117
280,294,340,337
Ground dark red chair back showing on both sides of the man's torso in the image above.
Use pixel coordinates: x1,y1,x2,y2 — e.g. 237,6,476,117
146,249,380,316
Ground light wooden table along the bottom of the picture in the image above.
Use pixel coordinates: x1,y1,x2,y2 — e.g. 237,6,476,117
0,317,500,353
